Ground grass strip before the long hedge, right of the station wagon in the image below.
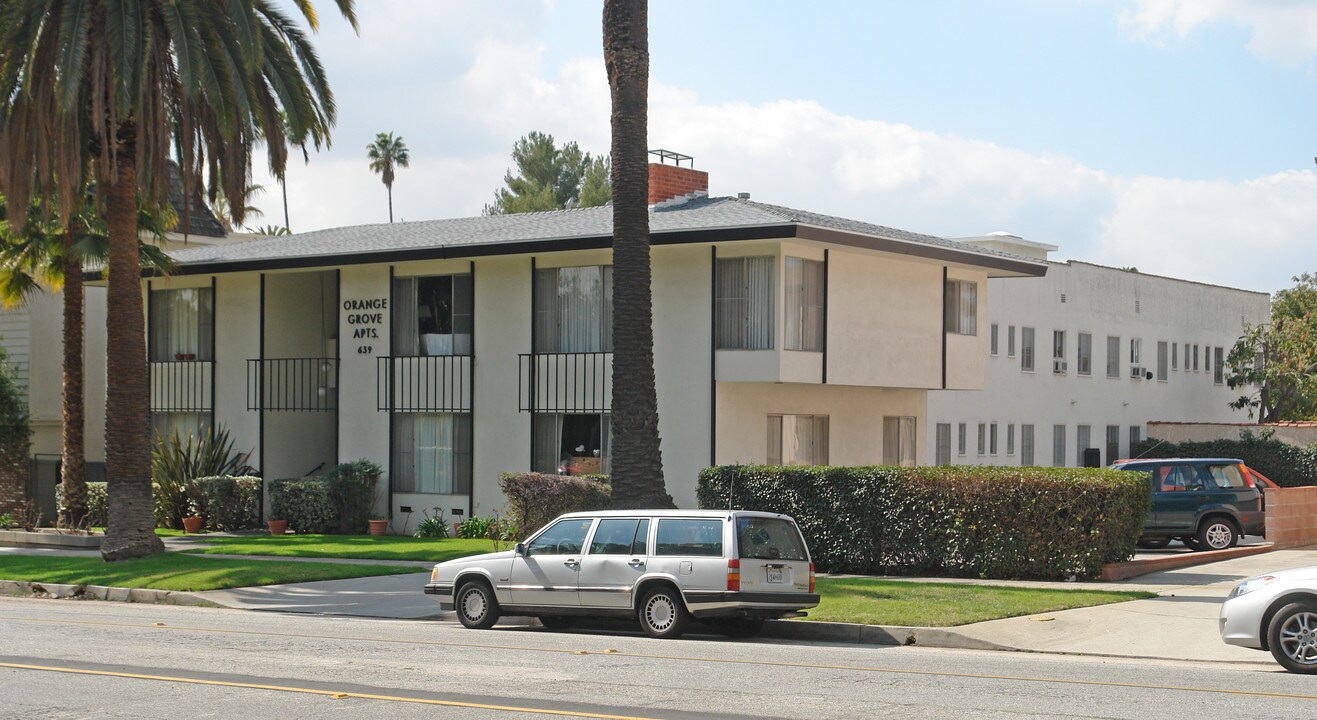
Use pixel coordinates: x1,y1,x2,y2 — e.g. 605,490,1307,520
809,578,1155,628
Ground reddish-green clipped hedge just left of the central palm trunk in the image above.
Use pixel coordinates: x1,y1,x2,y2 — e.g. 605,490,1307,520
497,473,612,538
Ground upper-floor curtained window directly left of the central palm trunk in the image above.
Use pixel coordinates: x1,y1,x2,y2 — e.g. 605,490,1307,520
535,265,612,353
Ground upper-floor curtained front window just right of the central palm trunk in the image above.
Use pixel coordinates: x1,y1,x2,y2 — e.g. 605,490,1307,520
714,257,773,350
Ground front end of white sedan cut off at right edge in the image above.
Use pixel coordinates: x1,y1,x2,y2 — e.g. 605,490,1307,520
1220,566,1317,674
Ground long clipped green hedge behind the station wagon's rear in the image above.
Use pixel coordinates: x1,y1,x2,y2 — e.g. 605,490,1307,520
698,466,1151,579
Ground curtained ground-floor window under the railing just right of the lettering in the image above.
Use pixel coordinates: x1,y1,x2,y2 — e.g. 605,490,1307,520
390,412,471,495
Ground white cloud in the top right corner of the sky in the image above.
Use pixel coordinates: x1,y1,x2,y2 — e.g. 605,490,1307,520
1119,0,1317,66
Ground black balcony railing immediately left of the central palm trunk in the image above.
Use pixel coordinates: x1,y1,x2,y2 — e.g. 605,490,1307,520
518,353,612,413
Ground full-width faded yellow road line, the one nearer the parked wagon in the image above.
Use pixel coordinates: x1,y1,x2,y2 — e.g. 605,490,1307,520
10,616,1317,700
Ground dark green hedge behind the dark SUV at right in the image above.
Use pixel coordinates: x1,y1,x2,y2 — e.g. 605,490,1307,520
1131,430,1317,487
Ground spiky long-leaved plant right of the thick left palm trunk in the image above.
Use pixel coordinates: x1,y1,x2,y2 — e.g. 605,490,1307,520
150,426,254,528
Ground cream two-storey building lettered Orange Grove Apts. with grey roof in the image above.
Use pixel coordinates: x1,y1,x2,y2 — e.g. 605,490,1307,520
144,165,1046,529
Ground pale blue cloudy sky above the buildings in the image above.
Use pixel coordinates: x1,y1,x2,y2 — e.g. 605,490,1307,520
250,0,1317,292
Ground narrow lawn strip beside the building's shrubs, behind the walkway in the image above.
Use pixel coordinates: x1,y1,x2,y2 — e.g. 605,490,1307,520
184,534,495,562
